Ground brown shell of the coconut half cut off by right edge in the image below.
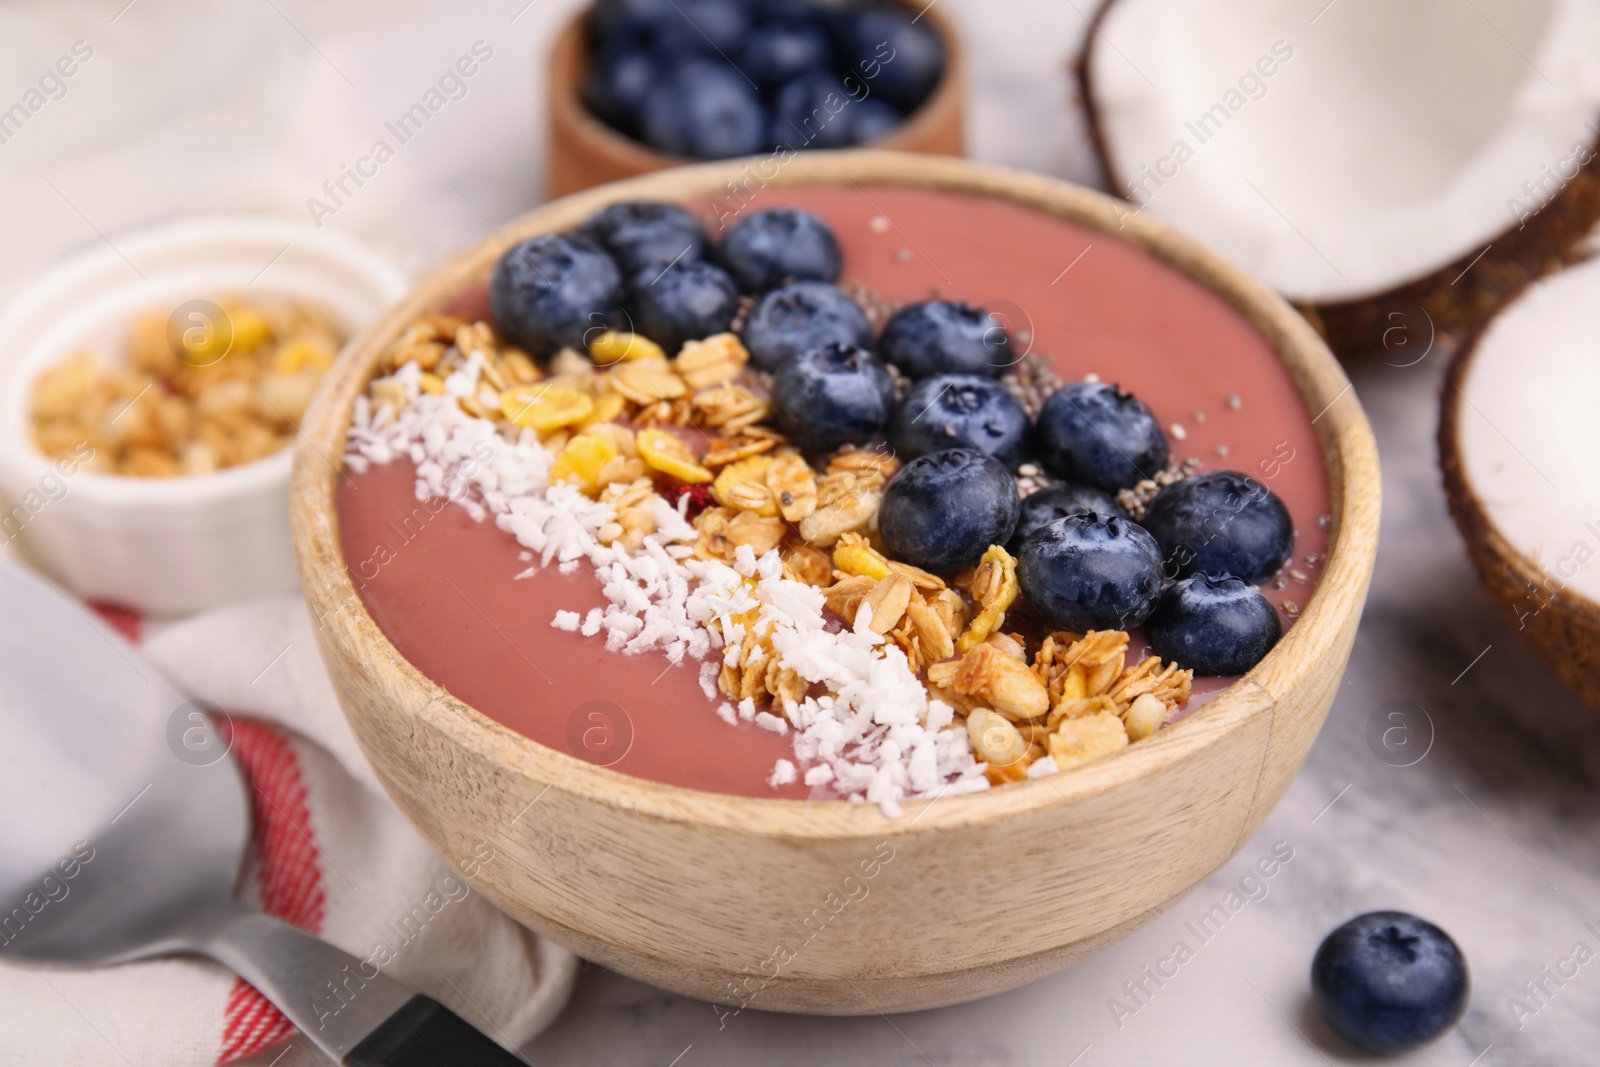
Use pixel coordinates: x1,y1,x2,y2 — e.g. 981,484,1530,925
1438,310,1600,710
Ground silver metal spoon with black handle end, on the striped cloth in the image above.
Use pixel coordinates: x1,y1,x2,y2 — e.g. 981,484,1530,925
0,565,523,1067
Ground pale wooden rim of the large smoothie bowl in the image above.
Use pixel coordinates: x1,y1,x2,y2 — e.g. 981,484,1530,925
291,150,1381,840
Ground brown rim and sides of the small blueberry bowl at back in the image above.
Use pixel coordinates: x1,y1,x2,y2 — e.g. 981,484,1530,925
549,0,965,173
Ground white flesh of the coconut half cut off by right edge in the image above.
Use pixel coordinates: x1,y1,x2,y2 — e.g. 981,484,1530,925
1456,251,1600,601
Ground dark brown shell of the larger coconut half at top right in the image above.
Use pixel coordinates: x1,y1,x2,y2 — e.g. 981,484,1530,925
1074,0,1600,360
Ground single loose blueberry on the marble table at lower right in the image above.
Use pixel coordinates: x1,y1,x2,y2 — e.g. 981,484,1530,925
1310,912,1472,1056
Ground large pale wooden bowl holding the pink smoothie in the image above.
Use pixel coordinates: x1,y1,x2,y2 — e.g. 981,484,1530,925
293,152,1379,1014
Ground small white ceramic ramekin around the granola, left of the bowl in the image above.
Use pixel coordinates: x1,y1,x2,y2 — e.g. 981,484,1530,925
0,219,406,614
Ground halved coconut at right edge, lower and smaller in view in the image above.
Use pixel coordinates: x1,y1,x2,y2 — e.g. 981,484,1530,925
1438,247,1600,709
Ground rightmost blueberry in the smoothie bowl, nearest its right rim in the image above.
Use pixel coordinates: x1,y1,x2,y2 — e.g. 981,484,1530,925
1144,470,1294,585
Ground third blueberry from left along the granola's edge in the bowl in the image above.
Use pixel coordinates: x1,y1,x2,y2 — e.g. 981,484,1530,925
773,342,894,453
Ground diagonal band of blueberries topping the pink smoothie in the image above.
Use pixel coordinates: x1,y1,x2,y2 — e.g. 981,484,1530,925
490,199,1294,675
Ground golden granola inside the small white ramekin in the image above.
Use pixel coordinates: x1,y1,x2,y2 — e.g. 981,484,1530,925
30,298,344,477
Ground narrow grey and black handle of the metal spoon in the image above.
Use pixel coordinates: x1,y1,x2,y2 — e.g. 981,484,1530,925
202,910,523,1067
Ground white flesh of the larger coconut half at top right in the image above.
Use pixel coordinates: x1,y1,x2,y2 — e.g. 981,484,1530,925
1086,0,1600,302
